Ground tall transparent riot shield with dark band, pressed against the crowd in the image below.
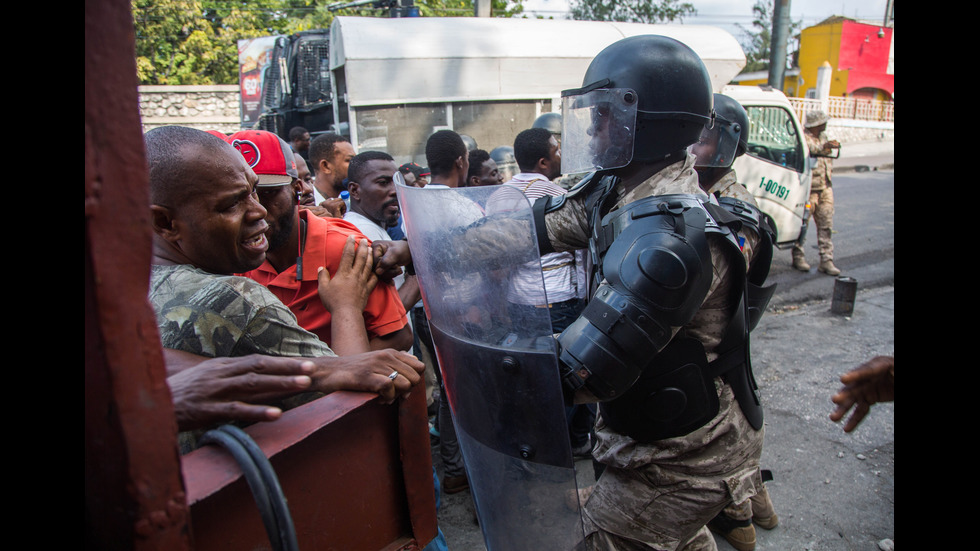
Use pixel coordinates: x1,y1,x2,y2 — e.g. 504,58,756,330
397,186,583,551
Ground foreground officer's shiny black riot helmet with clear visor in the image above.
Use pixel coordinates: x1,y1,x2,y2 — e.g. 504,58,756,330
562,35,712,172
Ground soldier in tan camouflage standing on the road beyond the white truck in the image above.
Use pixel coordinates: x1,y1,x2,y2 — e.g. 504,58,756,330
792,111,840,275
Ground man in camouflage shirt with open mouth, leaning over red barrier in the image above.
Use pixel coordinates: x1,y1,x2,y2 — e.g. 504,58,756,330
144,126,424,452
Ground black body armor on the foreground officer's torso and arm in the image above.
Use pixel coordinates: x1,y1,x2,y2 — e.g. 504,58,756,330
540,177,771,442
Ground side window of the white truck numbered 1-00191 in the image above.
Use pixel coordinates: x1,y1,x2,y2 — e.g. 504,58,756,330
746,106,806,173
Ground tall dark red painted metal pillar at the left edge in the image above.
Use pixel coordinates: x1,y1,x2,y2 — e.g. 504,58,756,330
84,0,191,550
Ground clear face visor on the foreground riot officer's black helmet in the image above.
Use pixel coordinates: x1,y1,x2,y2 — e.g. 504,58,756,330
561,88,637,174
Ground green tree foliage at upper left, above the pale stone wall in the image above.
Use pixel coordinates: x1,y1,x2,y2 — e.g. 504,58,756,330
131,0,524,85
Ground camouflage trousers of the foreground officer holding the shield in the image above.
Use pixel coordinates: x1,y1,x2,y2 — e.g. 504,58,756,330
583,379,764,551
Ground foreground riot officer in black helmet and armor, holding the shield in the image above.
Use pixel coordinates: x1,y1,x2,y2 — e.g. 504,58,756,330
534,35,763,550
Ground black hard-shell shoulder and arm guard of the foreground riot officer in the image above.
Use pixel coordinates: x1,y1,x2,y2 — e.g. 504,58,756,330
558,195,712,401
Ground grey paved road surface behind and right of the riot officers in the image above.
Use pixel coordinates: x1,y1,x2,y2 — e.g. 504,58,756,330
433,144,895,551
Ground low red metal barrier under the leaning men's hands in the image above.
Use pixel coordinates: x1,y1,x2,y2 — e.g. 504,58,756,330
183,392,436,551
